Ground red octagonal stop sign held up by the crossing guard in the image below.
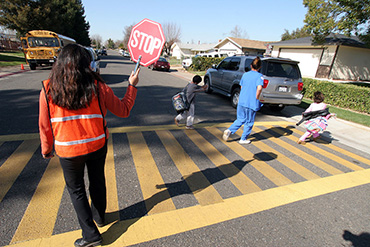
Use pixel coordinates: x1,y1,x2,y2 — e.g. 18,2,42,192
128,19,166,66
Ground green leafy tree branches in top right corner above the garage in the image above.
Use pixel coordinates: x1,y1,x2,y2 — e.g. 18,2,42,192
303,0,370,45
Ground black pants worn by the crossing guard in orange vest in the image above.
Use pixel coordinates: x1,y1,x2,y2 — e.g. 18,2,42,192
60,145,107,241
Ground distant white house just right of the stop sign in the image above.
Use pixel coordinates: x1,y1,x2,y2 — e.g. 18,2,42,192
171,42,215,59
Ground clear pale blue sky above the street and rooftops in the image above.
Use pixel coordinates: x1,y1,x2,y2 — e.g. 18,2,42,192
82,0,307,44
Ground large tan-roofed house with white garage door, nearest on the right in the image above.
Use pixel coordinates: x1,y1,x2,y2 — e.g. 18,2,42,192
270,34,370,81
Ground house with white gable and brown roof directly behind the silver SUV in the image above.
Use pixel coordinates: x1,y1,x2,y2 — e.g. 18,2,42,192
214,37,269,56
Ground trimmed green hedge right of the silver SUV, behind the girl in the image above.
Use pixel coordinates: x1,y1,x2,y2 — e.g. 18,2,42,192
302,78,370,114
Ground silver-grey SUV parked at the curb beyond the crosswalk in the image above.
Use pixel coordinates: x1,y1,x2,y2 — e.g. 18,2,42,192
204,56,303,110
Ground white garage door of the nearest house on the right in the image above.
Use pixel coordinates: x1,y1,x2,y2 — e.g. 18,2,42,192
279,49,322,77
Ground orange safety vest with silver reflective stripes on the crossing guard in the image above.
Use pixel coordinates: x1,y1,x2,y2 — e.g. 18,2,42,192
43,80,106,157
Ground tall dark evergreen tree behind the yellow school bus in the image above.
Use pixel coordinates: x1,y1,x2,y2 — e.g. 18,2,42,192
0,0,91,45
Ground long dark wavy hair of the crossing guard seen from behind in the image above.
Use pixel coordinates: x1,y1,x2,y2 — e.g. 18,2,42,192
49,44,101,110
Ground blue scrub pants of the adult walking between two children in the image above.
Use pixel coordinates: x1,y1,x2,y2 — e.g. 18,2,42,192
229,105,256,140
